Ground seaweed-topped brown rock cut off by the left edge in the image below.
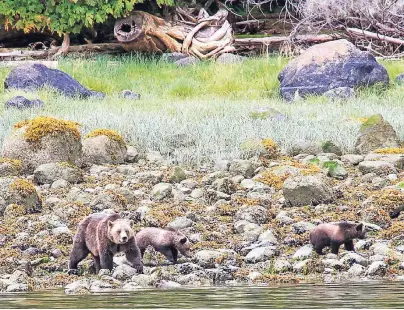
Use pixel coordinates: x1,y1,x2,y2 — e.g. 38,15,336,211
0,177,42,215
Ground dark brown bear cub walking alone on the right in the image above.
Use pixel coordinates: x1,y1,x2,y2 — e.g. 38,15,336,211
310,222,366,255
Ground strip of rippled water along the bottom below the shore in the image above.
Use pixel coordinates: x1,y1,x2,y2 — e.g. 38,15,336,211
0,282,404,309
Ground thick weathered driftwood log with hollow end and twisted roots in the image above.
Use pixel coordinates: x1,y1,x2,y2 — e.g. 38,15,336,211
114,8,235,59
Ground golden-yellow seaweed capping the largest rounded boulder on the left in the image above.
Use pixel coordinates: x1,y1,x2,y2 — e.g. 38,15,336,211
14,116,81,142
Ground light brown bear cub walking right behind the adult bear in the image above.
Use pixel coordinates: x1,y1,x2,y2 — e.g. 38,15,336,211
136,227,191,264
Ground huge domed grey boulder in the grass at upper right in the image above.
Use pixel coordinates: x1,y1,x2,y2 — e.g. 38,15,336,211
278,40,389,100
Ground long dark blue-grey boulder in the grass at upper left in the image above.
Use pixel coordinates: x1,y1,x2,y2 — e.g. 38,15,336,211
4,63,102,98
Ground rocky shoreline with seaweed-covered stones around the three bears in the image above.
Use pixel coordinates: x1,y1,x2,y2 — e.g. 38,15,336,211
0,109,404,294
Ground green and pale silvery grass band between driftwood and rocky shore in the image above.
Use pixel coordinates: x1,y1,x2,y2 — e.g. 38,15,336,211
0,57,404,167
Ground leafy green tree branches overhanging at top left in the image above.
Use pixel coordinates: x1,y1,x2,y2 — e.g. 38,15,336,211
0,0,174,55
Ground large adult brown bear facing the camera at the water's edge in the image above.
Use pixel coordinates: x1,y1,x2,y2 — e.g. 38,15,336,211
69,213,143,274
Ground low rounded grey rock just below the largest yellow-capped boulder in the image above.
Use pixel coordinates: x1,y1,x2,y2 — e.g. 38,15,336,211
34,163,83,184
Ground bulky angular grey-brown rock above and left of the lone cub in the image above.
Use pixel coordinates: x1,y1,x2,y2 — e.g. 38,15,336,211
283,175,334,207
